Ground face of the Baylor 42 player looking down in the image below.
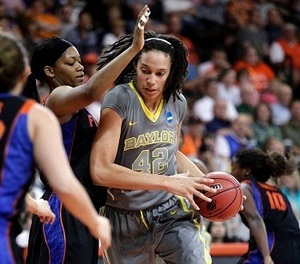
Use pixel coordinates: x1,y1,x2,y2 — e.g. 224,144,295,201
136,50,171,103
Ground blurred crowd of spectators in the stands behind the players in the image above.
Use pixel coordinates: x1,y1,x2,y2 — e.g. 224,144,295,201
0,0,300,252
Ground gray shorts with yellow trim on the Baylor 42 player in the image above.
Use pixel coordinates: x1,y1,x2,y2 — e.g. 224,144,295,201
103,196,212,264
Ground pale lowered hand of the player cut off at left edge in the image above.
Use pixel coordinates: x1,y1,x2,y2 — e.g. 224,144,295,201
90,216,111,251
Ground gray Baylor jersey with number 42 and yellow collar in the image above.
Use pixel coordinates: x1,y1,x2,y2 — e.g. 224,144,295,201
102,83,186,210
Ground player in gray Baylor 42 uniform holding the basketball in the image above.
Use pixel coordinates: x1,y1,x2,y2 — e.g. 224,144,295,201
90,32,215,264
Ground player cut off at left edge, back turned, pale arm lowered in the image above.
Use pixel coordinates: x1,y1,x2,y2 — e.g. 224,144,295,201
0,32,111,264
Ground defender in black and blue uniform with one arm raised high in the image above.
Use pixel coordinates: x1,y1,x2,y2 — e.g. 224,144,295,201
27,6,150,264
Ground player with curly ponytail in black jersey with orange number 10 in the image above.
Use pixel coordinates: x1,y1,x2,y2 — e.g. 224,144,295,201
231,149,300,264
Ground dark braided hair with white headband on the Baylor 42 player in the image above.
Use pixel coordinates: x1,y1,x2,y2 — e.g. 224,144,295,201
98,31,188,102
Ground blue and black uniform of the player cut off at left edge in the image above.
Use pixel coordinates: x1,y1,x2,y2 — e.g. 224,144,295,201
0,94,35,263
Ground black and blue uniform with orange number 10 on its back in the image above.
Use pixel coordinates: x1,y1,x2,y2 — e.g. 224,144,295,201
243,180,300,263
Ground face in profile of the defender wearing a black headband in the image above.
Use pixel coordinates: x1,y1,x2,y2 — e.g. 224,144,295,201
53,47,84,87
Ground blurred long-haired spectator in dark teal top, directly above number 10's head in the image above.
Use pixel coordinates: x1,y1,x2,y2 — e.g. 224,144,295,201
252,102,282,149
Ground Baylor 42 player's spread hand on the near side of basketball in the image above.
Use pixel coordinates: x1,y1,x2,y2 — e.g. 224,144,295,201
168,172,216,211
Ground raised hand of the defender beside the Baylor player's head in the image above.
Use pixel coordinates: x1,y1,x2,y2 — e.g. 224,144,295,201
132,5,151,51
